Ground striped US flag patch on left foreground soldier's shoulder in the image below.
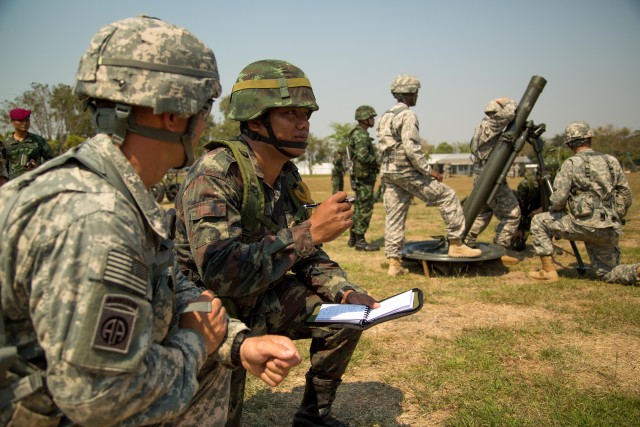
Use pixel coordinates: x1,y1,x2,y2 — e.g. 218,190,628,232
103,249,149,296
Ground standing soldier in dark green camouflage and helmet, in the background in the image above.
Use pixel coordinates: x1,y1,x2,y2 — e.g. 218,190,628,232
347,105,380,251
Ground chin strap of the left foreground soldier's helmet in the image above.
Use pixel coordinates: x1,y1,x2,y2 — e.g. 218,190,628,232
89,104,198,168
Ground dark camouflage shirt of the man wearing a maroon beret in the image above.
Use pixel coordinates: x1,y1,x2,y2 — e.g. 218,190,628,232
4,132,54,178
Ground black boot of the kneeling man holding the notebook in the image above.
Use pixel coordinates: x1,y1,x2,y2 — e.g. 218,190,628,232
293,370,349,427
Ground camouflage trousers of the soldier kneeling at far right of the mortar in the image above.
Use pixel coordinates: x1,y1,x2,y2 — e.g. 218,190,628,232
531,212,640,285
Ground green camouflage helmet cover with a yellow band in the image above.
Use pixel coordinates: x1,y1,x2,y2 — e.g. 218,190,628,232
229,59,319,122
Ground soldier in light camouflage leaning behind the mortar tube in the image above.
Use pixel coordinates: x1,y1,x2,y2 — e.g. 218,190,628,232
466,98,520,265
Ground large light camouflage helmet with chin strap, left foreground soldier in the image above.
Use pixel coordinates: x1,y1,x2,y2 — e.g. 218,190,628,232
74,16,221,166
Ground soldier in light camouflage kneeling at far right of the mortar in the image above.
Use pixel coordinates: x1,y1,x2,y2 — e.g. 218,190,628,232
529,122,640,285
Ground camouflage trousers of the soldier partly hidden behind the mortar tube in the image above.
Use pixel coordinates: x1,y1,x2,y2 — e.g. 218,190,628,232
466,174,520,248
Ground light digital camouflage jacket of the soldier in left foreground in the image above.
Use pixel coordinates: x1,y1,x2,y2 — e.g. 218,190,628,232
0,135,246,426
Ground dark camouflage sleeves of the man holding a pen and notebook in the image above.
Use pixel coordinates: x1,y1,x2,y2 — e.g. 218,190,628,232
176,149,362,307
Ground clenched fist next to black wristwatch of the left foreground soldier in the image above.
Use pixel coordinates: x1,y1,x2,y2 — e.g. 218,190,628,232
240,335,302,387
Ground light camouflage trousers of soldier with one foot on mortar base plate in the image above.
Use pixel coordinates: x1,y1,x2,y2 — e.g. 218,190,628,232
382,173,464,258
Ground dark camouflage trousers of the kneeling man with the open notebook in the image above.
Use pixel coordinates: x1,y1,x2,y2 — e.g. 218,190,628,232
226,274,362,426
